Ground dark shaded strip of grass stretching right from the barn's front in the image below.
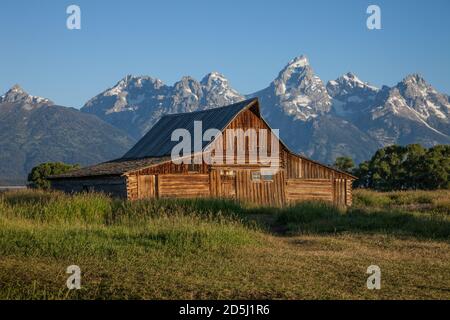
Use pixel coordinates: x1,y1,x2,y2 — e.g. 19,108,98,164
273,202,450,240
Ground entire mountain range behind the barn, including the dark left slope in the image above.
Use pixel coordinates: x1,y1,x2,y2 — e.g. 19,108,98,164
0,56,450,184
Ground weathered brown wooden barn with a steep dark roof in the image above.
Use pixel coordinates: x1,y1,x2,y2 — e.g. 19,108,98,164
50,99,355,207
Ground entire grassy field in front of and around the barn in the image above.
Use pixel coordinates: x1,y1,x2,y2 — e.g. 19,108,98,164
0,191,450,299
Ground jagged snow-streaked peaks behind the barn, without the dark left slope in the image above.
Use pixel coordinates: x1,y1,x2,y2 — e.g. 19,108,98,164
81,56,450,163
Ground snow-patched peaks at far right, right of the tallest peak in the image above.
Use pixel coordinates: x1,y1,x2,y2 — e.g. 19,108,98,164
327,75,450,147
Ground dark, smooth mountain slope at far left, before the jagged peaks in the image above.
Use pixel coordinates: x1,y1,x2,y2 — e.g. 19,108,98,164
0,86,134,185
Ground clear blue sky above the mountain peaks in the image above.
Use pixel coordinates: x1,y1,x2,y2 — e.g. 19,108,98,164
0,0,450,108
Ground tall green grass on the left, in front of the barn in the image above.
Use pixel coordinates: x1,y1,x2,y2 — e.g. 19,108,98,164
0,192,257,257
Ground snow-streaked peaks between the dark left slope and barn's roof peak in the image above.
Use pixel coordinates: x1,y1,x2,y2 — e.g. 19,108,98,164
81,72,243,139
